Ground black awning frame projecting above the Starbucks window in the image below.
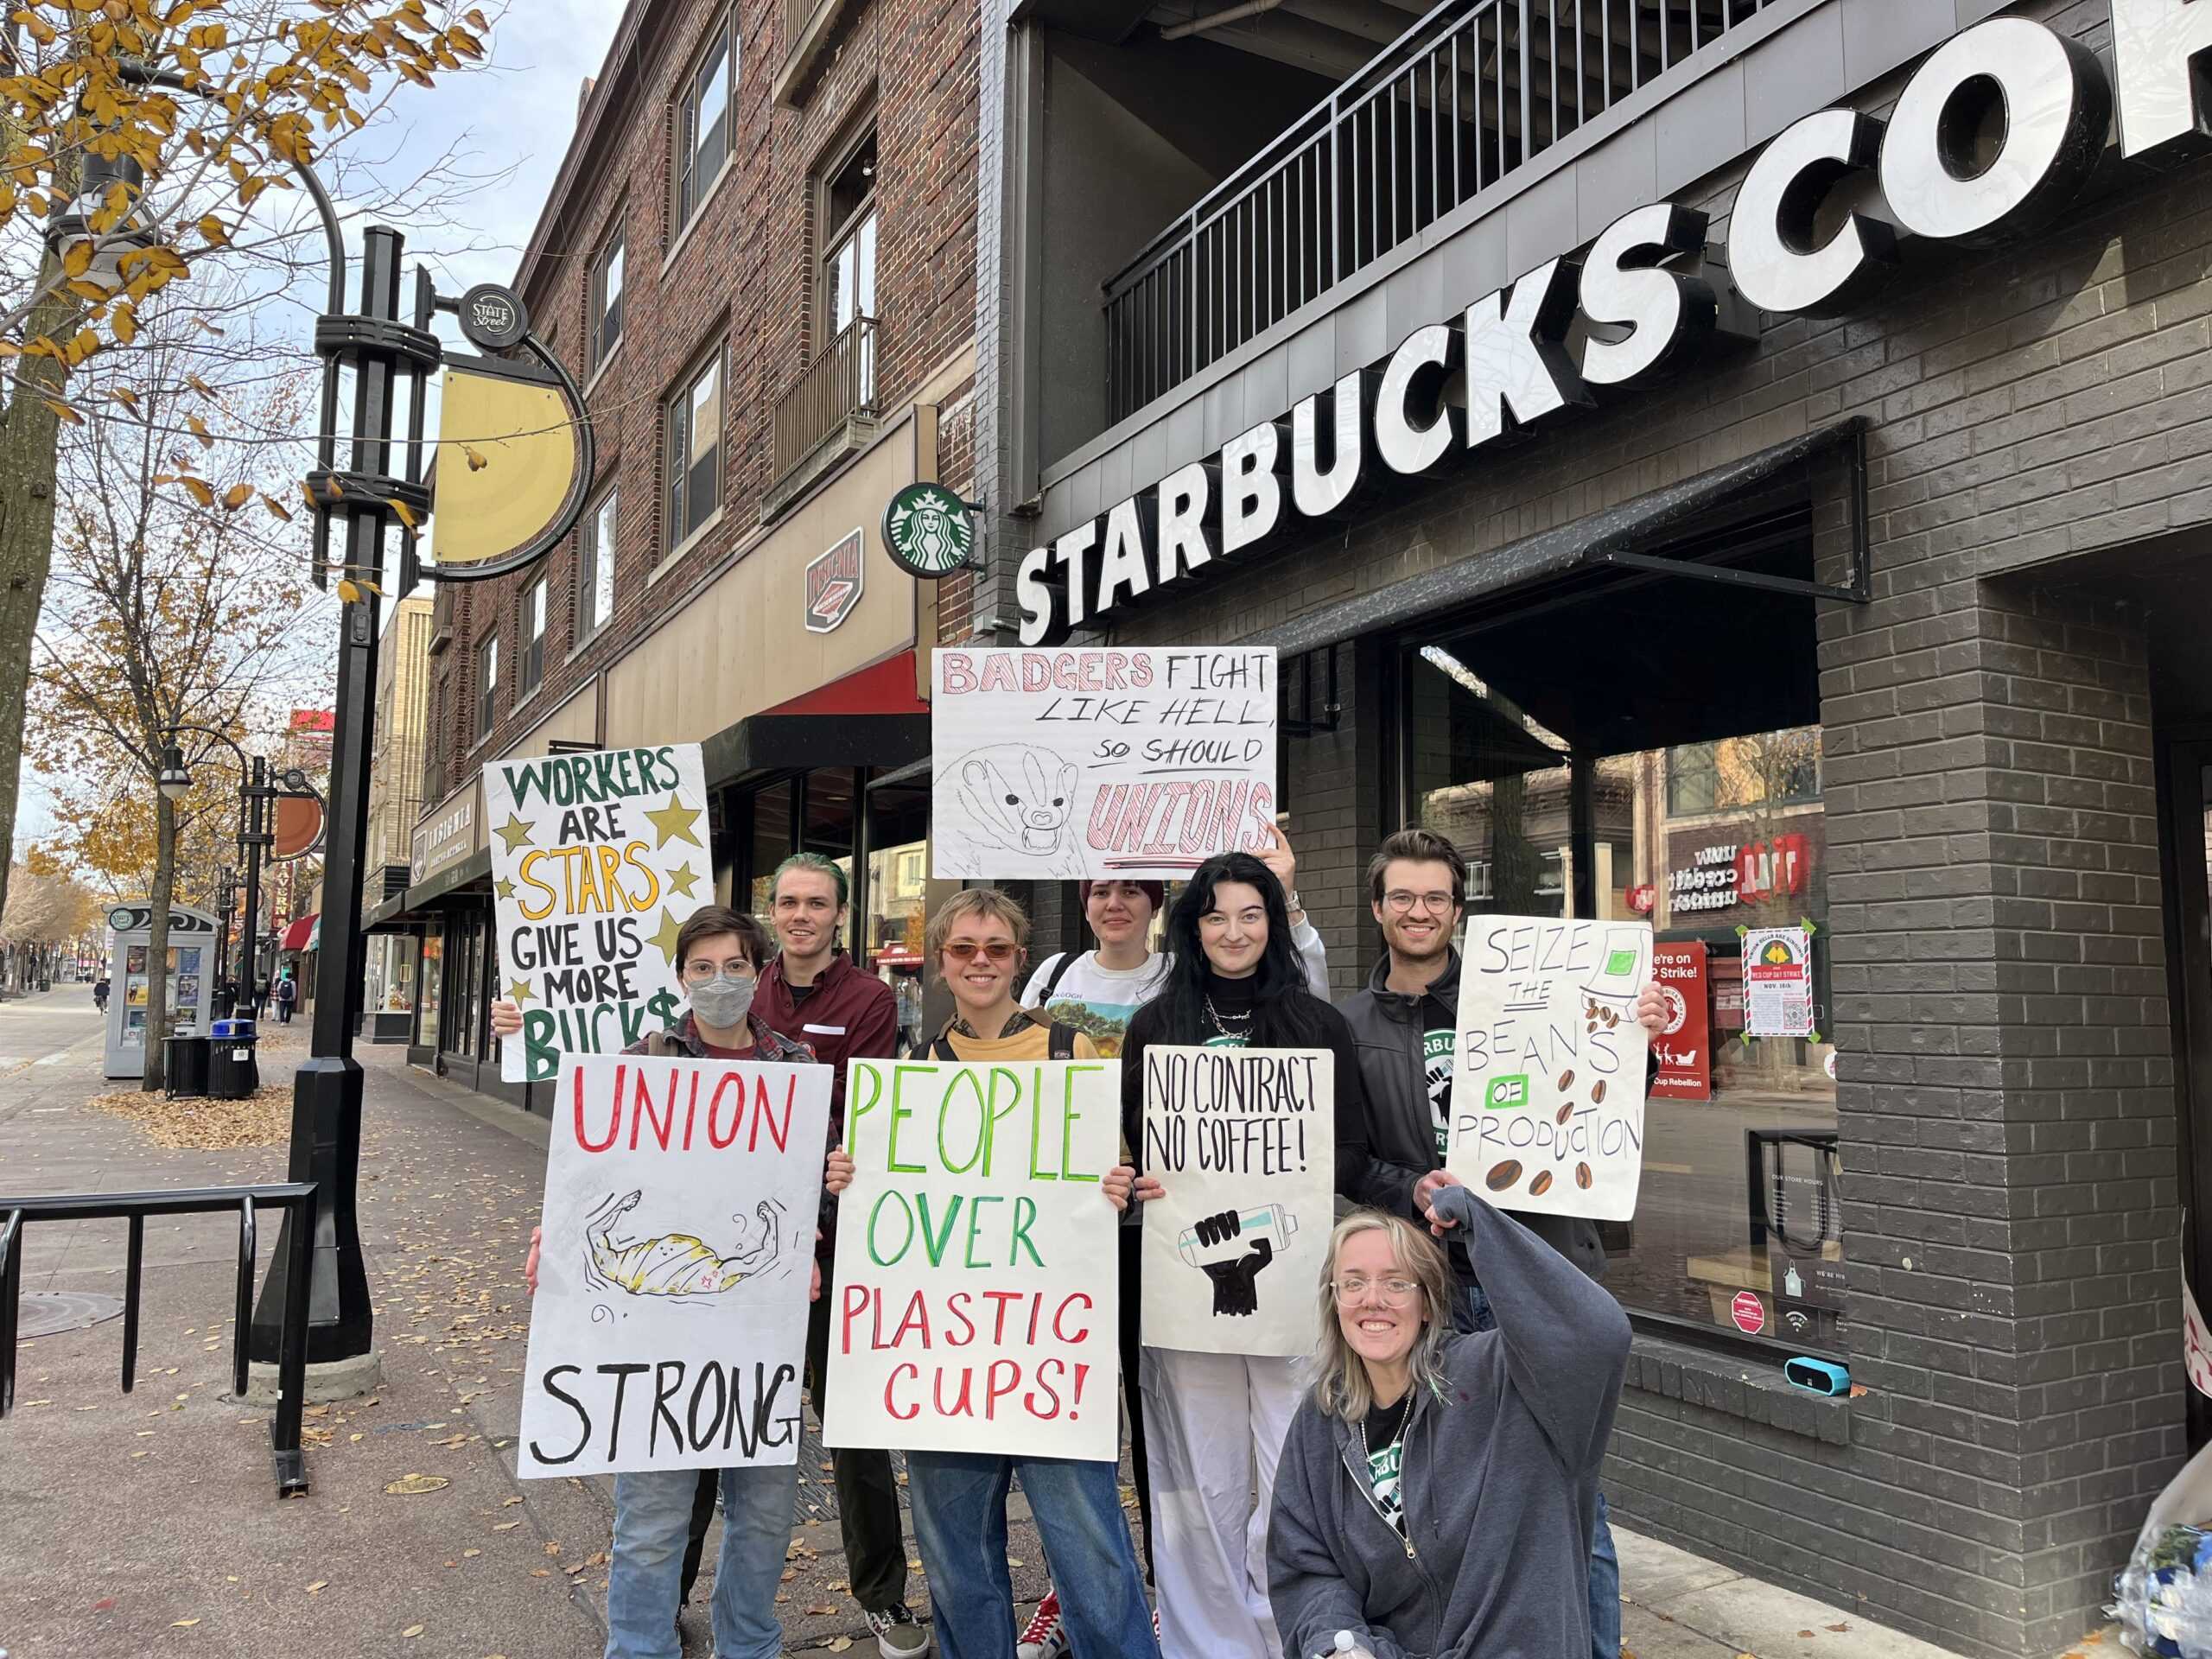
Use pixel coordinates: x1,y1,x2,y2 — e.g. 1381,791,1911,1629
1243,416,1867,657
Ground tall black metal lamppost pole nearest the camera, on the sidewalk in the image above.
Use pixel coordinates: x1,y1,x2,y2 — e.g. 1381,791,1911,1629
252,226,403,1365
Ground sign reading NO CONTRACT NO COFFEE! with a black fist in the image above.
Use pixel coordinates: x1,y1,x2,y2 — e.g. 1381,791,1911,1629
1141,1046,1336,1356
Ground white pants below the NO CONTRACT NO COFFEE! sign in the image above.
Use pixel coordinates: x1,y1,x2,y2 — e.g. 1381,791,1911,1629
1139,1347,1299,1659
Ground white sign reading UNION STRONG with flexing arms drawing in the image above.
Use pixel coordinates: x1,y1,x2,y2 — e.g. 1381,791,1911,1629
515,1053,832,1476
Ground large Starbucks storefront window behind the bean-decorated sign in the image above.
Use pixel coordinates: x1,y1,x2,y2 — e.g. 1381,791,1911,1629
1400,566,1845,1350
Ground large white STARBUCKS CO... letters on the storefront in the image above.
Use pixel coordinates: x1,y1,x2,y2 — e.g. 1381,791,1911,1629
1017,0,2212,646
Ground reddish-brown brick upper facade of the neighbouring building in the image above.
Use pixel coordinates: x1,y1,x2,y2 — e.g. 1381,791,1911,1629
431,0,976,798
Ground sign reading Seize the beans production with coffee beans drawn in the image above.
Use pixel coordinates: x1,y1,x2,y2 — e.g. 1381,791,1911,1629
1445,916,1652,1221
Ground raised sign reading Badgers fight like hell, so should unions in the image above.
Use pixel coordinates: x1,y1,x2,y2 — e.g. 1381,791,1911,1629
929,648,1276,880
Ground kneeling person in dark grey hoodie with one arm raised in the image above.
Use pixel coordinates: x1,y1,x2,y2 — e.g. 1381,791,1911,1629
1268,1185,1628,1659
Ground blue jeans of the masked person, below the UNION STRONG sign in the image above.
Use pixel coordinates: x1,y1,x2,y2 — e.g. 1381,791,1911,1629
606,1462,798,1659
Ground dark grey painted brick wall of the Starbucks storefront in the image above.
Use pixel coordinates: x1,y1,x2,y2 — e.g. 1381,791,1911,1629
1065,3,2212,1655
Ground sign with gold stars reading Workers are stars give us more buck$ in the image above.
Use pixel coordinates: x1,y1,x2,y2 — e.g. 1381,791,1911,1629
485,743,715,1084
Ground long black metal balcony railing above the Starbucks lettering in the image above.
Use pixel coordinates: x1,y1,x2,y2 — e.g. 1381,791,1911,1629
1106,0,1778,423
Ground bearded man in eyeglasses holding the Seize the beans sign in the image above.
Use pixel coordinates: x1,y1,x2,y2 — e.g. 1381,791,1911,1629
1336,830,1666,1659
